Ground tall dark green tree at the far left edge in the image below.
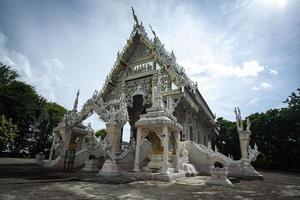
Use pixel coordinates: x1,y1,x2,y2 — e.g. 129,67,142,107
0,63,45,153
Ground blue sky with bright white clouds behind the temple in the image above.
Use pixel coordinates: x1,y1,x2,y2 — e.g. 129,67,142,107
0,0,300,141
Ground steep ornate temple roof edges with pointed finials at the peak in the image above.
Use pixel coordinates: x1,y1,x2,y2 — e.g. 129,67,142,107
100,9,215,122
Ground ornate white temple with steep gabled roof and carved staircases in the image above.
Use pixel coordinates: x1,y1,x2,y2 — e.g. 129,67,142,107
46,9,261,180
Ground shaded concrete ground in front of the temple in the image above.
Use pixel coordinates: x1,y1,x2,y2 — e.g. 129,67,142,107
0,158,300,200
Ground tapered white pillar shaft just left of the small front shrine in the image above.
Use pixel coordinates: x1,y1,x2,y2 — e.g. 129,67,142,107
106,122,123,155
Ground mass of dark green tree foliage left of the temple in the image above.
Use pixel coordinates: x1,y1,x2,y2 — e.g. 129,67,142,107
0,63,66,154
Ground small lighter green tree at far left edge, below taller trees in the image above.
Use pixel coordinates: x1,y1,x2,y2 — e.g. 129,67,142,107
0,115,18,150
